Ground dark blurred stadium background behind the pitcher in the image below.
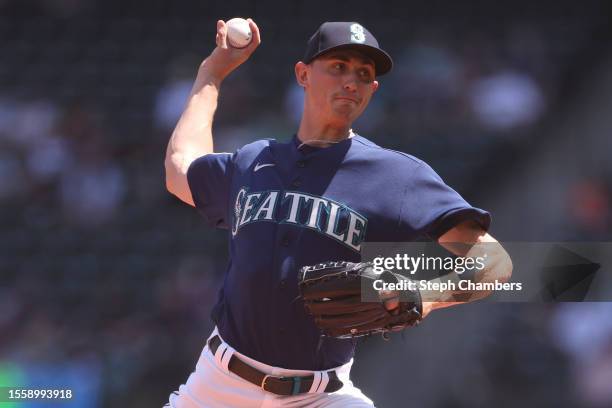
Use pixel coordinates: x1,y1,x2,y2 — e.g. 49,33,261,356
0,0,612,408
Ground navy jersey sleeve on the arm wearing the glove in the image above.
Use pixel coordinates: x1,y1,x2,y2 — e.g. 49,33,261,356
400,163,491,240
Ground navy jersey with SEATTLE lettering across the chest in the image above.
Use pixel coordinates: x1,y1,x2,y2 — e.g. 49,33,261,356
187,135,490,370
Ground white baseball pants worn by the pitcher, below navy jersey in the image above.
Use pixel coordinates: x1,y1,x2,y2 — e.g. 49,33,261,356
165,328,374,408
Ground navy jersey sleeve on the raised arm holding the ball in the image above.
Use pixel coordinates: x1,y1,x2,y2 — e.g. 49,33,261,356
187,153,234,229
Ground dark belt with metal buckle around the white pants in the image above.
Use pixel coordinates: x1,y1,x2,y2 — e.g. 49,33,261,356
208,335,343,395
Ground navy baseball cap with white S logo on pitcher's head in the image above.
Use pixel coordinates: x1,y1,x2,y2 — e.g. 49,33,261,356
303,21,393,75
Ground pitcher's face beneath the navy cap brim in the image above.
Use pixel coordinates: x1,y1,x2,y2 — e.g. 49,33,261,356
298,50,378,125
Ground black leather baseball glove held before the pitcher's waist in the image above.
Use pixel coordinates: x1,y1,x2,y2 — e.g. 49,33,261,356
298,262,423,339
